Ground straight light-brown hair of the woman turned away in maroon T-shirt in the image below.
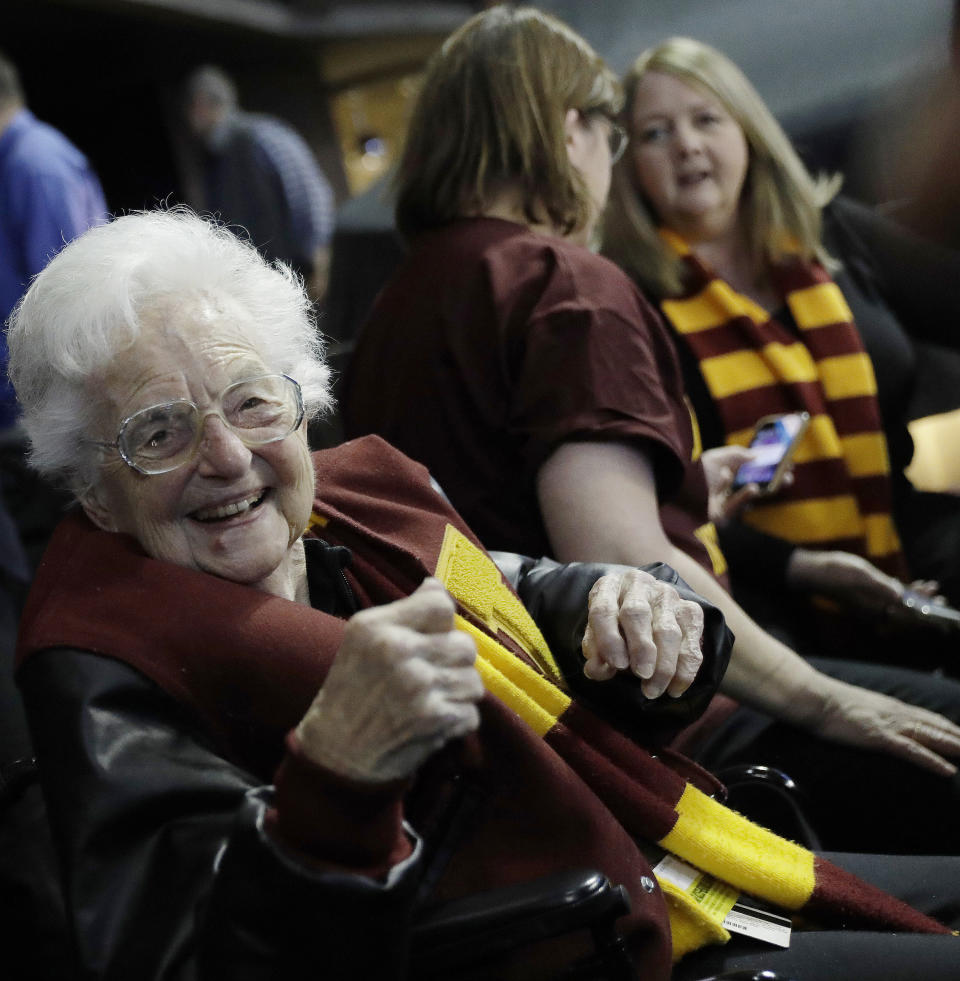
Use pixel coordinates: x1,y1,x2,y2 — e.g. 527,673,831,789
396,5,623,238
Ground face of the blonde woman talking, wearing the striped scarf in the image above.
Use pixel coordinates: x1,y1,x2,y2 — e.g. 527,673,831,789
629,71,750,244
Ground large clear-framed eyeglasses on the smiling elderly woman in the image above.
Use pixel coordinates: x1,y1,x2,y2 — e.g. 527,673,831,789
86,375,303,475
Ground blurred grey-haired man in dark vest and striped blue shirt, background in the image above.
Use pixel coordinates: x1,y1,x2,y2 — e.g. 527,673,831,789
186,65,335,303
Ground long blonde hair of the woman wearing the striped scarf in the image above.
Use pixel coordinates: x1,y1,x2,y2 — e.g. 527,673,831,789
603,37,841,298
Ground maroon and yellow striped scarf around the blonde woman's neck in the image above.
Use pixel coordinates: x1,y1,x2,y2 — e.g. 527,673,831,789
661,232,903,574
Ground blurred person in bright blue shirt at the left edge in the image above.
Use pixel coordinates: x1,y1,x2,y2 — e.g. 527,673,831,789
0,47,98,981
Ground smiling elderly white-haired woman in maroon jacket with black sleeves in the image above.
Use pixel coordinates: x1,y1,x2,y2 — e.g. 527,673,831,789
3,210,729,981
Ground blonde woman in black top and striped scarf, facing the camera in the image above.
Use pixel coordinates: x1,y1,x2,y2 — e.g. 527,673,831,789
603,38,960,663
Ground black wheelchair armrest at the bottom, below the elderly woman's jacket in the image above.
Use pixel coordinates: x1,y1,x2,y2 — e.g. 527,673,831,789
411,870,635,978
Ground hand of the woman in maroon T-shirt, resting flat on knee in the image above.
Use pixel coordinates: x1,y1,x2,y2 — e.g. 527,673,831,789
801,681,960,777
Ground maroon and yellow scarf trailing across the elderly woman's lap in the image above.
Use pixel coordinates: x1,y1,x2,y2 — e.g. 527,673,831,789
436,526,948,960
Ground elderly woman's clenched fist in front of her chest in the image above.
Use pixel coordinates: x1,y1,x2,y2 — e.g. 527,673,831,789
297,579,484,781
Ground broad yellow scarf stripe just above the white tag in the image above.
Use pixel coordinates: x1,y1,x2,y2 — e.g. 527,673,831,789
660,784,816,909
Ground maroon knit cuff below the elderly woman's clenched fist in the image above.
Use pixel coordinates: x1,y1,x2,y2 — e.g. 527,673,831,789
266,732,413,878
